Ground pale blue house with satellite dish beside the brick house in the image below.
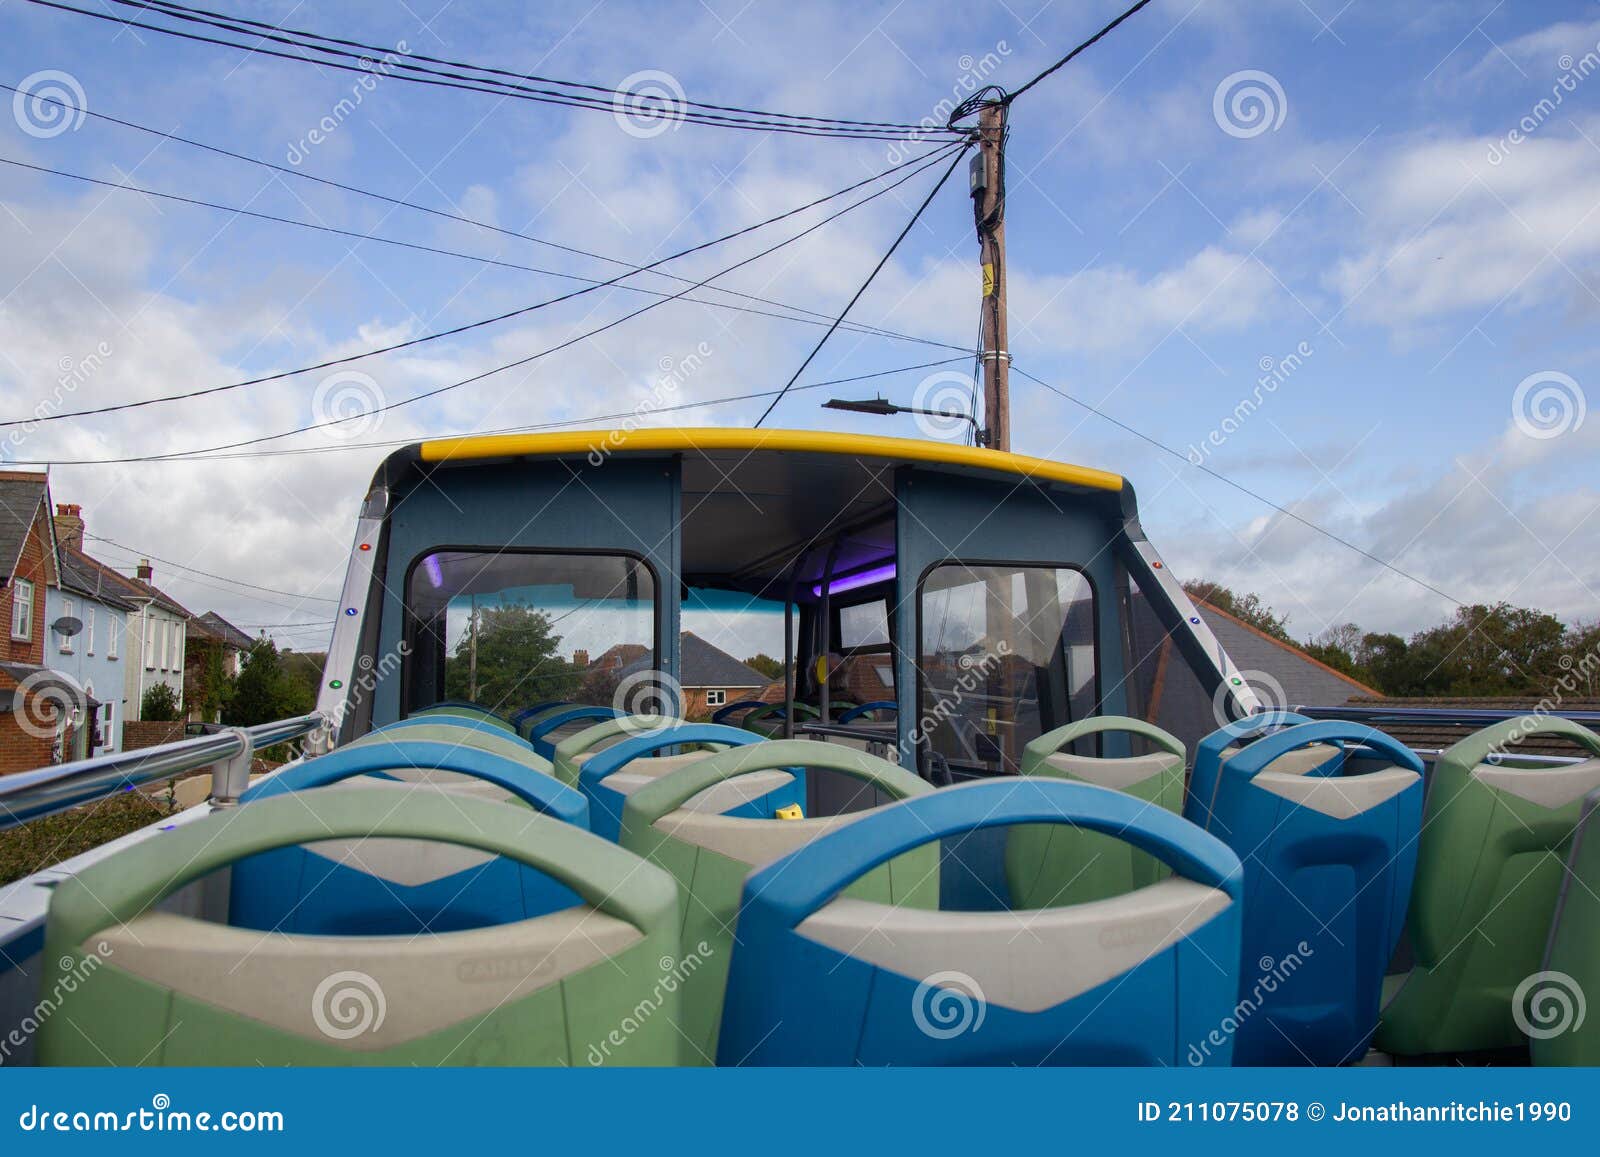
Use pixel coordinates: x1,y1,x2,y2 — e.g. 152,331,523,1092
45,502,134,759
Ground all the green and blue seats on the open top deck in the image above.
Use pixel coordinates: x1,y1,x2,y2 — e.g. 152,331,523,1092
40,704,1600,1064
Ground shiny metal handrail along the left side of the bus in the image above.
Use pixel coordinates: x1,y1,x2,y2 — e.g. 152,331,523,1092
0,712,326,831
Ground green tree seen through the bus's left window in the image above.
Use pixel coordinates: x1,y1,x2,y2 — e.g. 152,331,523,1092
445,603,584,711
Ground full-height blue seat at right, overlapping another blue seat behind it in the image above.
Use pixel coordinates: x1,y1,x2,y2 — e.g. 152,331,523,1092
1213,720,1422,1064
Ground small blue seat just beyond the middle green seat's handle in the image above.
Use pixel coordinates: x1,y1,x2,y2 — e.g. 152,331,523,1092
578,722,774,840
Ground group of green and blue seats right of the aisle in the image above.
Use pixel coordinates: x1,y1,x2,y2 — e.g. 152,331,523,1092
1006,712,1600,1064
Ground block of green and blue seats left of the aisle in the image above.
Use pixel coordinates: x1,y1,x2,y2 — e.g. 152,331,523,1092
31,704,1240,1064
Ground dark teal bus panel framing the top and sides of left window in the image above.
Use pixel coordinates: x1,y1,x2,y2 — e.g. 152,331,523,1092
371,458,682,727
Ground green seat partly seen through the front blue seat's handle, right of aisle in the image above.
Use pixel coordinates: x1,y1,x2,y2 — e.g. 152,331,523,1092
1005,715,1184,907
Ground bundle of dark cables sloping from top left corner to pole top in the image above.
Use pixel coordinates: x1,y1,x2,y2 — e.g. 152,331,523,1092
30,0,947,141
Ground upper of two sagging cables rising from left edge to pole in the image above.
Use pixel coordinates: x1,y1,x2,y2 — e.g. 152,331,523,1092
0,146,962,427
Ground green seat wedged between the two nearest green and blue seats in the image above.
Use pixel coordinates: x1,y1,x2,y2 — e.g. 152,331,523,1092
614,739,939,1059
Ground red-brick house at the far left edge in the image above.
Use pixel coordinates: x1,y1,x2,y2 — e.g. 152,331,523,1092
0,470,76,775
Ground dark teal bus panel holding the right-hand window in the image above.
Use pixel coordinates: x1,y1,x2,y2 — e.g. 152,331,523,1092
894,467,1126,783
